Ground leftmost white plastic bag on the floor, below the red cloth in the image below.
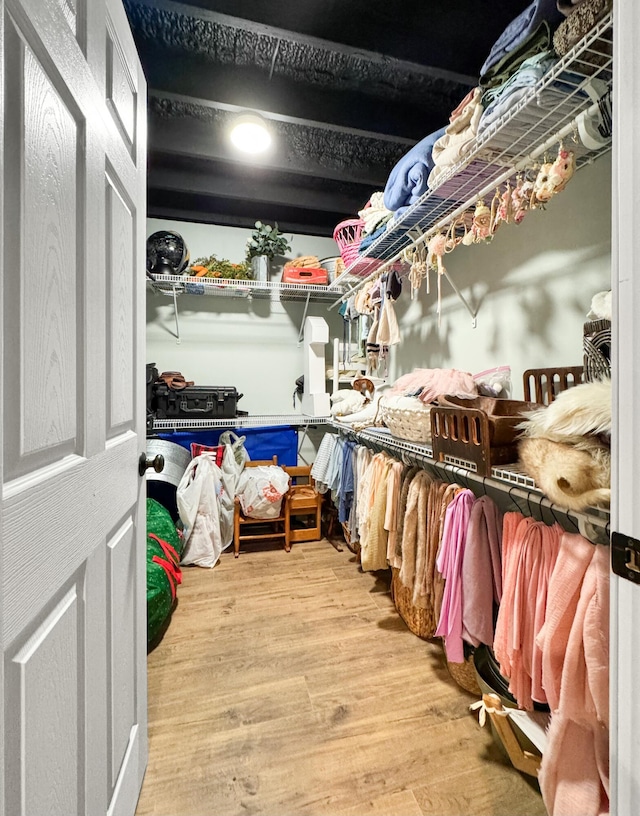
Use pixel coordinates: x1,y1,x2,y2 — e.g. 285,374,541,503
177,453,228,567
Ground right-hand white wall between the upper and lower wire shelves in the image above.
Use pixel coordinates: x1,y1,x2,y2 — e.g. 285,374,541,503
390,156,611,399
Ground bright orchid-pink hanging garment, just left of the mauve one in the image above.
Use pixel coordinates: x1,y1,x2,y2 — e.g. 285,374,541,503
436,490,475,663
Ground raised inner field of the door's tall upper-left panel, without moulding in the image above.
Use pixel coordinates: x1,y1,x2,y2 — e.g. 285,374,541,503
21,47,82,465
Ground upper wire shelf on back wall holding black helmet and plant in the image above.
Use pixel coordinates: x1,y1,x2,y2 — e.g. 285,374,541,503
148,275,343,301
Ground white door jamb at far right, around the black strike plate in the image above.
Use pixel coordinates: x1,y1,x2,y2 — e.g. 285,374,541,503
608,0,640,816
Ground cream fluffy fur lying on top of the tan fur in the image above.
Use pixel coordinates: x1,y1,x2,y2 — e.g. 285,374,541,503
518,380,611,445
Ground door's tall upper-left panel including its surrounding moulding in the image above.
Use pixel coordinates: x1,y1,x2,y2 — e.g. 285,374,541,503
3,17,80,483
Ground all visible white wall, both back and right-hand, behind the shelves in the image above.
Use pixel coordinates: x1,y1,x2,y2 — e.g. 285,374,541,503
147,157,611,434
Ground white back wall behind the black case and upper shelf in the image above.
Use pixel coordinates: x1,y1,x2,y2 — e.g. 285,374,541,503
147,219,342,414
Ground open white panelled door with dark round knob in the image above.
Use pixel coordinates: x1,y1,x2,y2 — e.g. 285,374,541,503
0,0,147,816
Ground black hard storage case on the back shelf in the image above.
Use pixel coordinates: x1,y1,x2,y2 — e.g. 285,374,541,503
154,382,242,419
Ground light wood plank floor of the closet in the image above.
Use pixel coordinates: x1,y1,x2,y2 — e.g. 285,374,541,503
137,540,545,816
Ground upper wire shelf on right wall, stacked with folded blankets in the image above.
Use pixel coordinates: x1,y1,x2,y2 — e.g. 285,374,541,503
329,13,613,290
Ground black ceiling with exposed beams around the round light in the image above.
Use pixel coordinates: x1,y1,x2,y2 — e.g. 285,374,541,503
125,0,529,235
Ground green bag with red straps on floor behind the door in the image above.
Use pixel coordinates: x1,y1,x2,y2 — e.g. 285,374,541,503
147,499,182,645
